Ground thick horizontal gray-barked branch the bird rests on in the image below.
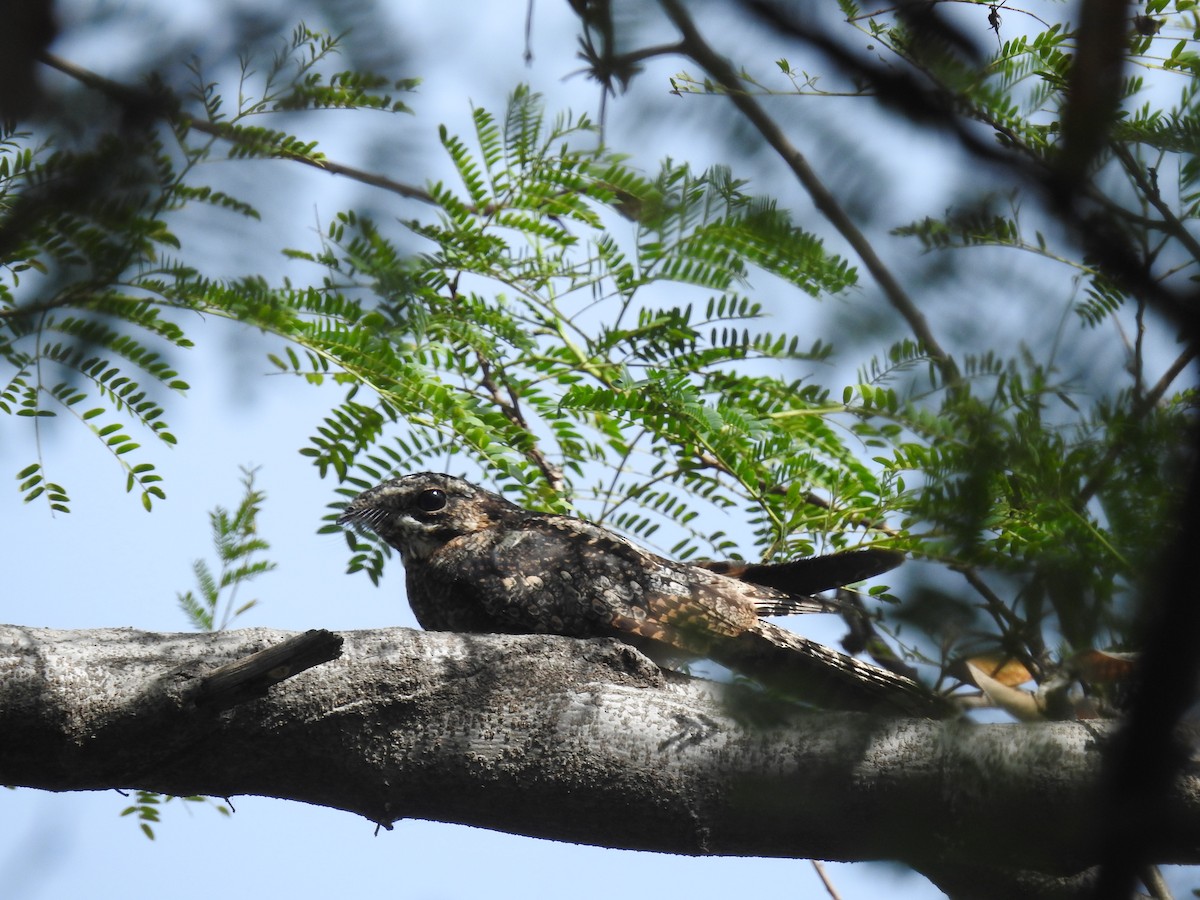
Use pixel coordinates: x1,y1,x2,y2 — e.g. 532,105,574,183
0,626,1200,896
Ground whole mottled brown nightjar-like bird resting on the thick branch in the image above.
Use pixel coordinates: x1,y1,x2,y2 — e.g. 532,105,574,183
338,473,944,715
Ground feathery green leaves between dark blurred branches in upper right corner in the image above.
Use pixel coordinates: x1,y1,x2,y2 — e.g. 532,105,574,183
848,0,1200,326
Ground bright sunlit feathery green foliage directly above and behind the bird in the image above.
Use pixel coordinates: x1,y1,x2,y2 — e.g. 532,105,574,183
253,88,878,578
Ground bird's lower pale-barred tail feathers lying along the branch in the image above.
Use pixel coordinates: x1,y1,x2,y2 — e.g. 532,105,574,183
708,622,954,719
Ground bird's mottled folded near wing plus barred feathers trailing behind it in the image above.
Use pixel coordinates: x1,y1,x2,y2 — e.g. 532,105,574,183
475,516,946,715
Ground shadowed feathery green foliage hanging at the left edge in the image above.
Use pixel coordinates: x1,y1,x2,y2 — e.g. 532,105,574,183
0,25,414,512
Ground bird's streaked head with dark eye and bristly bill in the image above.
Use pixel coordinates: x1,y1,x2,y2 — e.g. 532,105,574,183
337,472,523,562
